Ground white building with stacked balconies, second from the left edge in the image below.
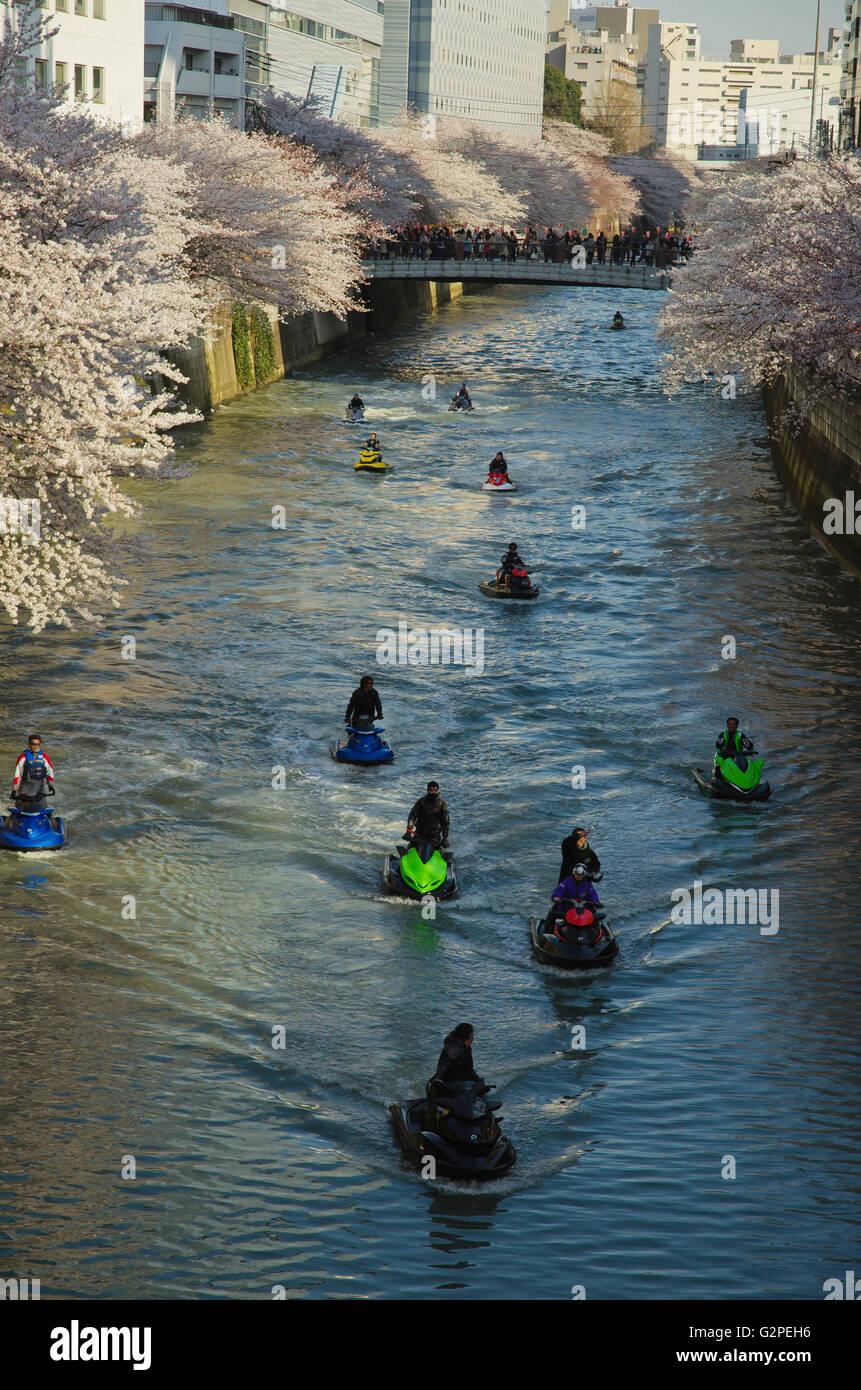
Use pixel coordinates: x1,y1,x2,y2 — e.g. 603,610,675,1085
143,0,245,126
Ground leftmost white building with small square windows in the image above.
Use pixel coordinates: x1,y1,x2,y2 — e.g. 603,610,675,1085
9,0,143,133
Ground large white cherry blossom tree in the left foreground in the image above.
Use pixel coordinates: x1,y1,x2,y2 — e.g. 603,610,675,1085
0,78,206,630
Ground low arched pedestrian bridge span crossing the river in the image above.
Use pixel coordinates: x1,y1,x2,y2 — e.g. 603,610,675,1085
364,256,675,289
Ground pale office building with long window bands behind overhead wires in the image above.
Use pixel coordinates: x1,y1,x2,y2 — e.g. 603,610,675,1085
230,0,383,125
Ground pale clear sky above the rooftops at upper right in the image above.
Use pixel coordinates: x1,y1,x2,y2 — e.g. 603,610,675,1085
574,0,844,57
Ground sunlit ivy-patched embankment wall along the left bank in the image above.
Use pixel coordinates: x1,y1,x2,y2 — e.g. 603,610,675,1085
168,281,472,414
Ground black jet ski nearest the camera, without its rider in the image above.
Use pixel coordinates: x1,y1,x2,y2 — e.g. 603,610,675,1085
389,1079,517,1180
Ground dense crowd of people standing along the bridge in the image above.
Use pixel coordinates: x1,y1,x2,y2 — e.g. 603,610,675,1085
366,222,694,270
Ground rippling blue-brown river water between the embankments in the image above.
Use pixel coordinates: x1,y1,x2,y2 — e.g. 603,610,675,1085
0,288,861,1300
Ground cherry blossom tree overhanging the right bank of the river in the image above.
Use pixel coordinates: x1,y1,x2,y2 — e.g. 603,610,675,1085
661,154,861,416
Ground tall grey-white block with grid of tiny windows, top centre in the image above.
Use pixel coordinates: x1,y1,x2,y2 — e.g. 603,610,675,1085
380,0,547,140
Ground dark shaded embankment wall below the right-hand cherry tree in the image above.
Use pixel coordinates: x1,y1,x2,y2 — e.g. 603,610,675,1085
764,373,861,575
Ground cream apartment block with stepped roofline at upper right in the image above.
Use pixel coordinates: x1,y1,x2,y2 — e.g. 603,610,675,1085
643,24,840,161
